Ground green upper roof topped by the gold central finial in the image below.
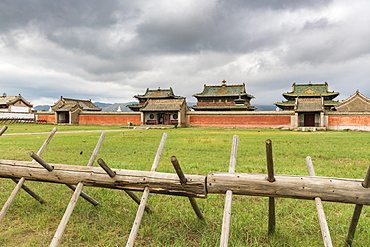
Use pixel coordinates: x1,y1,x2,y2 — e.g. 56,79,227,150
193,80,254,98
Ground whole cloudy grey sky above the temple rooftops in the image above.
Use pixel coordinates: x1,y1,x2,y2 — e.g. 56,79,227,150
0,0,370,106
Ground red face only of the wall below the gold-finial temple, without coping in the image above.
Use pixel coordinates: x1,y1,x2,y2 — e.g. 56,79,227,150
189,115,291,128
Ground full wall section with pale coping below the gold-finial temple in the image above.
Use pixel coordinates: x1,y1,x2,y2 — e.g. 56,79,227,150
187,111,294,129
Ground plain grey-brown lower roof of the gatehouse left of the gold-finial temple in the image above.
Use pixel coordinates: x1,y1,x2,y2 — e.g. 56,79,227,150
140,99,186,111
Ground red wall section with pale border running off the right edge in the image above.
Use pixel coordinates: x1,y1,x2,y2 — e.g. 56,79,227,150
327,112,370,131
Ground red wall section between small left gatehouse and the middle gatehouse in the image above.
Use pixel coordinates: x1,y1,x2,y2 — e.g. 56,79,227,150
79,114,141,125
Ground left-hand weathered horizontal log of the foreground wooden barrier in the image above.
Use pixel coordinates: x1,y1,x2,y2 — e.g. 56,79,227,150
0,159,207,198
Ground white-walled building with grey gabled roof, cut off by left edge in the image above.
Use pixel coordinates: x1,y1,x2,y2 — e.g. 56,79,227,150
0,93,33,113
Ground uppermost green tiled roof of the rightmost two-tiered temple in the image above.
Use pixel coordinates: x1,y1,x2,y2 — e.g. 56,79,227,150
283,82,339,98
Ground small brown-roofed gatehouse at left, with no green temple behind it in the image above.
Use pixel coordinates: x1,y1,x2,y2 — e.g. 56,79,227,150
50,96,101,124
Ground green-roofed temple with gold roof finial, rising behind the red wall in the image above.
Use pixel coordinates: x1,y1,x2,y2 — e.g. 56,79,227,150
191,80,256,111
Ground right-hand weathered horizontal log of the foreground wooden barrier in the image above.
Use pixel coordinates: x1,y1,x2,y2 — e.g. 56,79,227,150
207,172,370,205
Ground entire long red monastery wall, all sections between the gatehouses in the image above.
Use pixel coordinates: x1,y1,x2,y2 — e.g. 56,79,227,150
35,111,370,131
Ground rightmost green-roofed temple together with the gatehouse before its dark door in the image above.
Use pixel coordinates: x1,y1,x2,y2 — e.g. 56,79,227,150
275,82,339,127
